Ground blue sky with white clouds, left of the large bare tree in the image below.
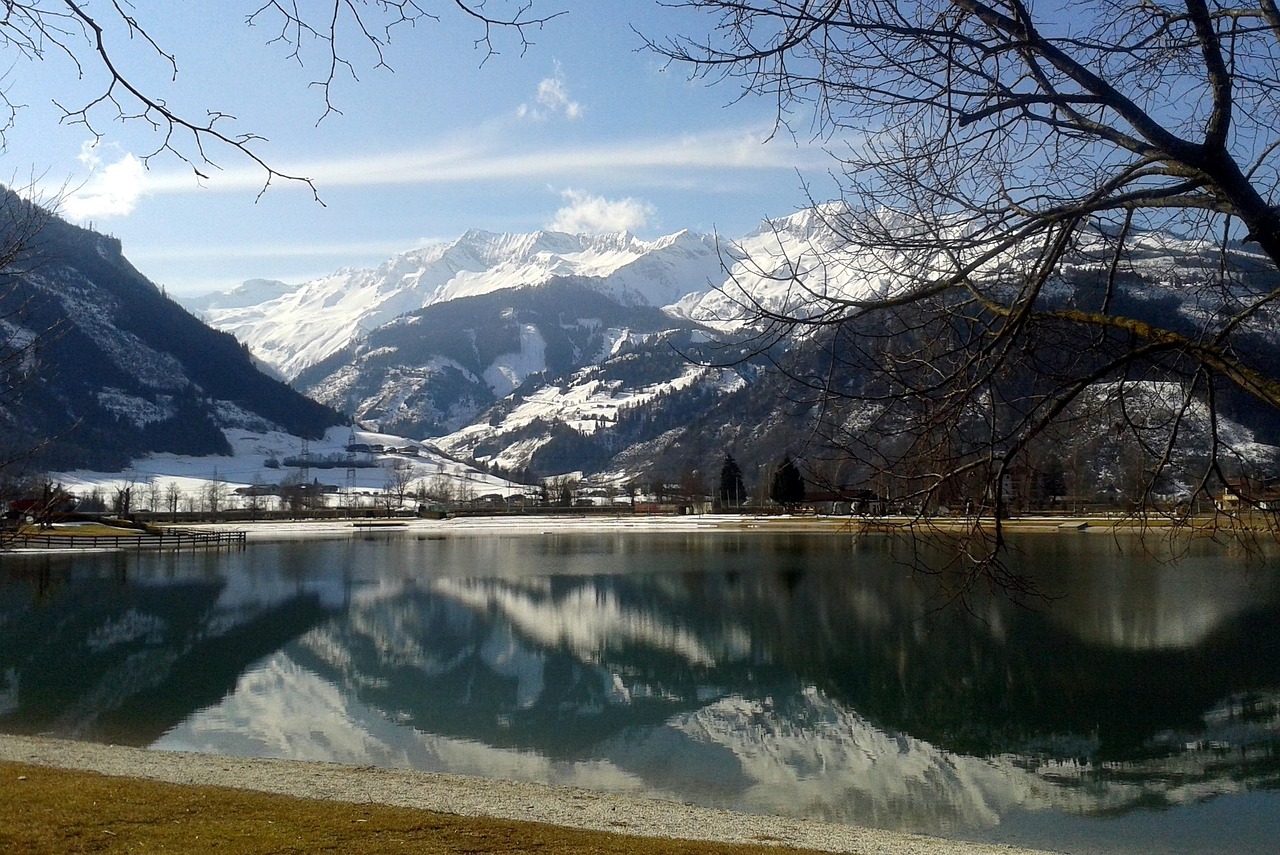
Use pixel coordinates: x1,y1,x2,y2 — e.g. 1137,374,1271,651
4,0,829,293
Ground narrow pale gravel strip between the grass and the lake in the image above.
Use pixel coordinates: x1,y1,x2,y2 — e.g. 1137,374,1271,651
0,736,1059,855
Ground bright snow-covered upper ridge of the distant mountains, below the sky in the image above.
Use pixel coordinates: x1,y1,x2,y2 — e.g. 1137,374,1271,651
177,211,859,379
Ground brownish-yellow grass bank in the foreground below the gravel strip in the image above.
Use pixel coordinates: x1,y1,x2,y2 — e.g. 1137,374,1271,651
0,763,819,855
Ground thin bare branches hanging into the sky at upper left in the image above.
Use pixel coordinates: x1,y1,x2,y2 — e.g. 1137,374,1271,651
0,0,558,198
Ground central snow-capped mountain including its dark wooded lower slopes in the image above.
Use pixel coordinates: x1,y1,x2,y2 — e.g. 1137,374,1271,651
177,210,860,479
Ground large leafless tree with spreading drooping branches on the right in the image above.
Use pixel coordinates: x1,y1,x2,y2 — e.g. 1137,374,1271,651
650,0,1280,593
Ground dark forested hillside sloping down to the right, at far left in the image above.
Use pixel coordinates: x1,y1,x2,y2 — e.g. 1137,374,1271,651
0,191,342,468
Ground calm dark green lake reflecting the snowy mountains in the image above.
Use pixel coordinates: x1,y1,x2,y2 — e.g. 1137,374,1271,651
0,531,1280,852
